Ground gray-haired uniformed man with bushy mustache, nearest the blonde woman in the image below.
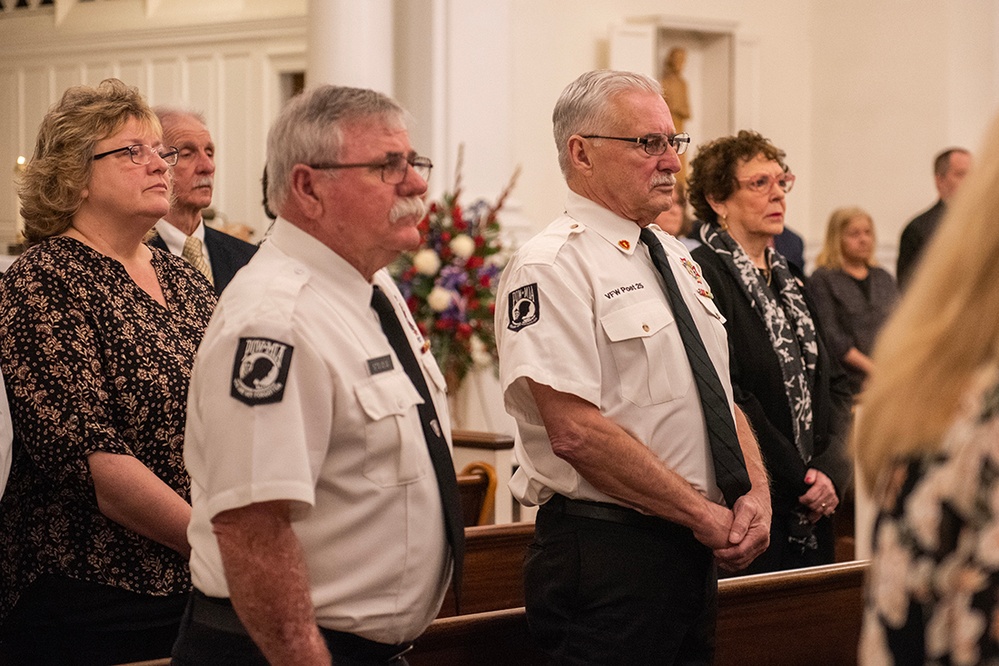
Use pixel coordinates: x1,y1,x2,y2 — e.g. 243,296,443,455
173,86,464,666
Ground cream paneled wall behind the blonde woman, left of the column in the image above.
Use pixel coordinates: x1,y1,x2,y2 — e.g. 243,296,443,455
0,0,305,249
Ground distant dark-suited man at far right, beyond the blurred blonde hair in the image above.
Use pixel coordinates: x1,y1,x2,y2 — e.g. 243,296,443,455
895,148,971,290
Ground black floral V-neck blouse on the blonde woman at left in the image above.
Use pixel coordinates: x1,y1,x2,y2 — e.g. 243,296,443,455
0,237,215,623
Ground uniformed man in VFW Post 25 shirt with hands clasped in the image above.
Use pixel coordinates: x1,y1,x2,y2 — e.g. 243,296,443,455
496,71,770,665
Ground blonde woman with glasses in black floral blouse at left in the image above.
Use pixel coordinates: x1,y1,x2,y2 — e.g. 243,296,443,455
0,79,215,664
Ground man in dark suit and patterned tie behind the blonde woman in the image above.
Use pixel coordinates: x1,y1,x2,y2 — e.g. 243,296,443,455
149,107,257,294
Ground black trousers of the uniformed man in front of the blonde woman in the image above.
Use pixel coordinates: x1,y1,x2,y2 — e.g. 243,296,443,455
171,589,411,666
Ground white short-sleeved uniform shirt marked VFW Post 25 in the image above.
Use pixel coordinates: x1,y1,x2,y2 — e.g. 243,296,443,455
496,192,734,505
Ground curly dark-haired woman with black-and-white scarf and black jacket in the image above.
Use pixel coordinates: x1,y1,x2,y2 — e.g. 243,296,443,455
688,131,850,573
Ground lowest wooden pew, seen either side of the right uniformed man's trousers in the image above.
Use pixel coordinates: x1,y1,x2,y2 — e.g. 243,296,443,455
407,562,867,666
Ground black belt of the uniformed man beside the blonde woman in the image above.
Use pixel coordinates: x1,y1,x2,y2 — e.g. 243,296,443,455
191,589,413,664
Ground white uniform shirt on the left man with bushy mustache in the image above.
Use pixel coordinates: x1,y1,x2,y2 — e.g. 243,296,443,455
184,219,451,643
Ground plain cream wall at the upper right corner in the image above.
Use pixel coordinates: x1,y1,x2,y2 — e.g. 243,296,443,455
808,0,999,273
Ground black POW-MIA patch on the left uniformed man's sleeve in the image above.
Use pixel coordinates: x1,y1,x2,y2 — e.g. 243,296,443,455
230,338,295,407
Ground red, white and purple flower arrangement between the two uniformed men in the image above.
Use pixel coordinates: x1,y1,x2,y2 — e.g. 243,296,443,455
389,149,519,391
